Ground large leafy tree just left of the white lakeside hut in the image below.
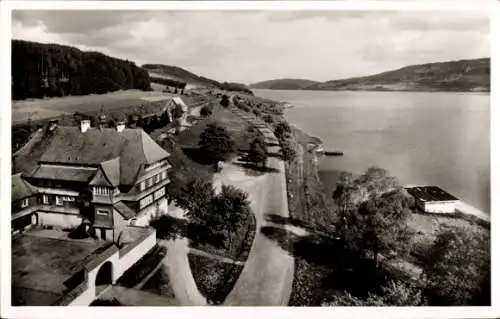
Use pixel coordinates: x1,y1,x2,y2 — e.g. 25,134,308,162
333,167,411,267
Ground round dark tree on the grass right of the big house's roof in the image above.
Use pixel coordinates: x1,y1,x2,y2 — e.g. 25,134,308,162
198,123,235,164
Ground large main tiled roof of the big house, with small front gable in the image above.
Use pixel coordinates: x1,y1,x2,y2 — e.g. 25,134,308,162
15,126,169,185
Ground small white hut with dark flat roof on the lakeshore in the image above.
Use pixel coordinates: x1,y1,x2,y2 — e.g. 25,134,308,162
406,186,460,213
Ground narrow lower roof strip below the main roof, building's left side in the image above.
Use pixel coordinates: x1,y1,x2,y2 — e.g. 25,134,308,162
31,164,97,183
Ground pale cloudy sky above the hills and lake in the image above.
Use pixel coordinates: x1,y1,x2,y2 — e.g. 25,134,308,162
12,10,490,84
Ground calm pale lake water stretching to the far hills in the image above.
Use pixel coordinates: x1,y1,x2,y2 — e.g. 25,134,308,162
255,90,490,214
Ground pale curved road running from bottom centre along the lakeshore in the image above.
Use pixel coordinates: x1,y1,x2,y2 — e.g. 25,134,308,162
214,106,294,306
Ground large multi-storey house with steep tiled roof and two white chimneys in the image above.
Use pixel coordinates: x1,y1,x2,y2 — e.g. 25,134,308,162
12,120,170,241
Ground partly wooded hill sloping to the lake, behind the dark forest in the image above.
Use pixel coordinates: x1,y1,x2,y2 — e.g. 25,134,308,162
142,64,253,94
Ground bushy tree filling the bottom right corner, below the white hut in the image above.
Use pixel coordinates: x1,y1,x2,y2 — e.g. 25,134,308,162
424,228,491,306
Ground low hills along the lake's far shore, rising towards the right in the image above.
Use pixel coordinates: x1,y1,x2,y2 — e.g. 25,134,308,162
251,58,490,92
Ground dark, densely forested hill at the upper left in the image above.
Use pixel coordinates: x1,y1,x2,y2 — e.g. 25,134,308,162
12,40,151,100
